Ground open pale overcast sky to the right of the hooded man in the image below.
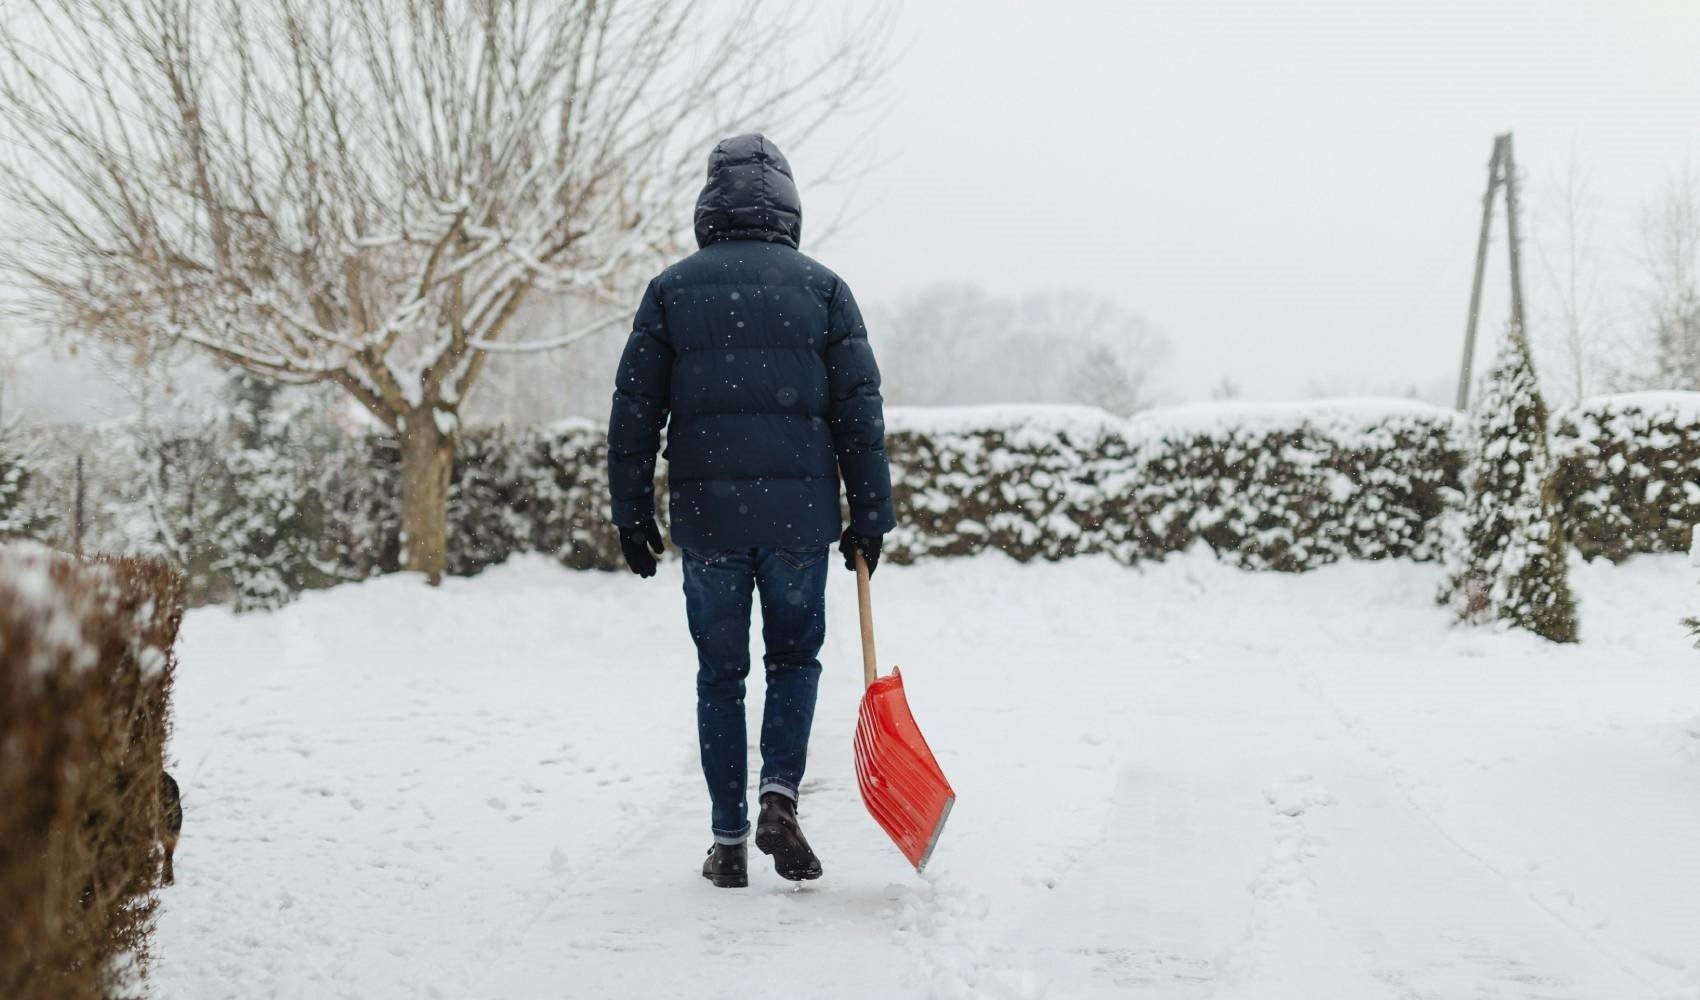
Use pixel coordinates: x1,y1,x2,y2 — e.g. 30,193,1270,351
796,0,1700,398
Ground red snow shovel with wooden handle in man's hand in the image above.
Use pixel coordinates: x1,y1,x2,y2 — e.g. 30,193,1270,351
855,553,955,872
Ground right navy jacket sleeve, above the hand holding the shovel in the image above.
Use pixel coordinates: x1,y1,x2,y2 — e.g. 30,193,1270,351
826,282,898,534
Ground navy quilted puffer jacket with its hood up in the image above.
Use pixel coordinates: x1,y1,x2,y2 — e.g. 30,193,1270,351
609,134,896,549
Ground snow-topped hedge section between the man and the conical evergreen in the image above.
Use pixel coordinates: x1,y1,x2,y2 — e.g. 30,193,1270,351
887,400,1462,571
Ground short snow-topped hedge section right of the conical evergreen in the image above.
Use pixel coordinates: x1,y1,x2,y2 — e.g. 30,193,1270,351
1556,393,1700,561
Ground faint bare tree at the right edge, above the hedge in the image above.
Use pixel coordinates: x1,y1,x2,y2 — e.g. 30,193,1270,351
1641,167,1700,389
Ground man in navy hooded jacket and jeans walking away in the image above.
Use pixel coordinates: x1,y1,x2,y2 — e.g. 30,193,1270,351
609,134,896,886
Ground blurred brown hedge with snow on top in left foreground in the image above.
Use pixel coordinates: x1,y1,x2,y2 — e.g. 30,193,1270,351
0,544,185,1000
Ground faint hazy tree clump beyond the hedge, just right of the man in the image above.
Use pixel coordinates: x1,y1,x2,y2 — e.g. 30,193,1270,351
874,284,1168,413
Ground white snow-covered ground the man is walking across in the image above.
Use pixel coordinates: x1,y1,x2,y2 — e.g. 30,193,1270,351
155,554,1700,998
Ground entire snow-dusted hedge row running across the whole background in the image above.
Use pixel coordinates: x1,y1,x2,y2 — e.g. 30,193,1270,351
19,395,1700,607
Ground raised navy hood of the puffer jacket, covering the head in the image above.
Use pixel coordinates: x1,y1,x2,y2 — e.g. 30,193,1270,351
697,133,802,250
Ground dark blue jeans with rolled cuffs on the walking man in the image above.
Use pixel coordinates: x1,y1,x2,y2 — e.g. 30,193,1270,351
685,546,830,844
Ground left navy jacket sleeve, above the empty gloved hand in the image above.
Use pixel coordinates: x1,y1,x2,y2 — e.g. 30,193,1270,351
609,281,673,527
